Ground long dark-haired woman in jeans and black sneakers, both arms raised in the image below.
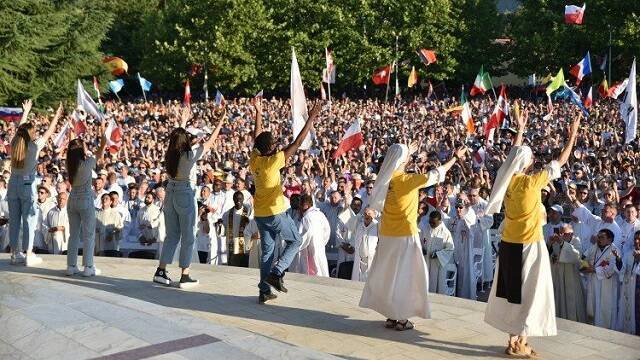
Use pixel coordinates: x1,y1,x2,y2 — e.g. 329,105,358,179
153,107,227,288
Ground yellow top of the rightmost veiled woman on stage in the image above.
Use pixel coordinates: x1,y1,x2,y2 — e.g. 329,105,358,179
502,169,552,244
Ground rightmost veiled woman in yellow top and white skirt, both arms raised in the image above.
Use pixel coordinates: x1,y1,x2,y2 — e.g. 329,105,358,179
484,112,580,357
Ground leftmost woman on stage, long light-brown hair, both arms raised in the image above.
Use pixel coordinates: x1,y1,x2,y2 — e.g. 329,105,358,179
7,100,63,266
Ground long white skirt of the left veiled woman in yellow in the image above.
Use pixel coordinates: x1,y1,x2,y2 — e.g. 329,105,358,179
360,235,431,320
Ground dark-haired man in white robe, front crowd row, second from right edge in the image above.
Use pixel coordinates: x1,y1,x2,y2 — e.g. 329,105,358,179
581,229,620,330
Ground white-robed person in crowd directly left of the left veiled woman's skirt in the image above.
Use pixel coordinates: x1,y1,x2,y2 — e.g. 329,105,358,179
351,208,378,282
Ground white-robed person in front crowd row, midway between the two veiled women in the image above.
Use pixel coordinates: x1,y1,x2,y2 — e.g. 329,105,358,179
450,193,482,300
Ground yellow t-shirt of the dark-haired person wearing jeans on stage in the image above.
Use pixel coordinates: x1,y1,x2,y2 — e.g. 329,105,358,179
249,150,287,217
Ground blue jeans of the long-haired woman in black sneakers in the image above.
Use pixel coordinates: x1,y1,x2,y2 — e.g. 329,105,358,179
160,180,198,269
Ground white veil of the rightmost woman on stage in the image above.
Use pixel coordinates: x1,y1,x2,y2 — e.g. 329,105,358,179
485,145,533,215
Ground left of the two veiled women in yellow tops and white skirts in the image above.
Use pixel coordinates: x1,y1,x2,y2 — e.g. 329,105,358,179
360,144,466,331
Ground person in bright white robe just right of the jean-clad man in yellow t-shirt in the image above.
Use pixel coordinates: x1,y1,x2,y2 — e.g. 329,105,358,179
300,195,331,277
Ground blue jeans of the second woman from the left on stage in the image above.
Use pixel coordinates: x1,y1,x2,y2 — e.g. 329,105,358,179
67,192,96,267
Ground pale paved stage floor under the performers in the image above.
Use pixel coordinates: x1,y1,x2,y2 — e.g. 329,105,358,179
0,254,640,360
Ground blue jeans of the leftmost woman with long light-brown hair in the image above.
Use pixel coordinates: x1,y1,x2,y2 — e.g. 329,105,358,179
7,175,38,253
